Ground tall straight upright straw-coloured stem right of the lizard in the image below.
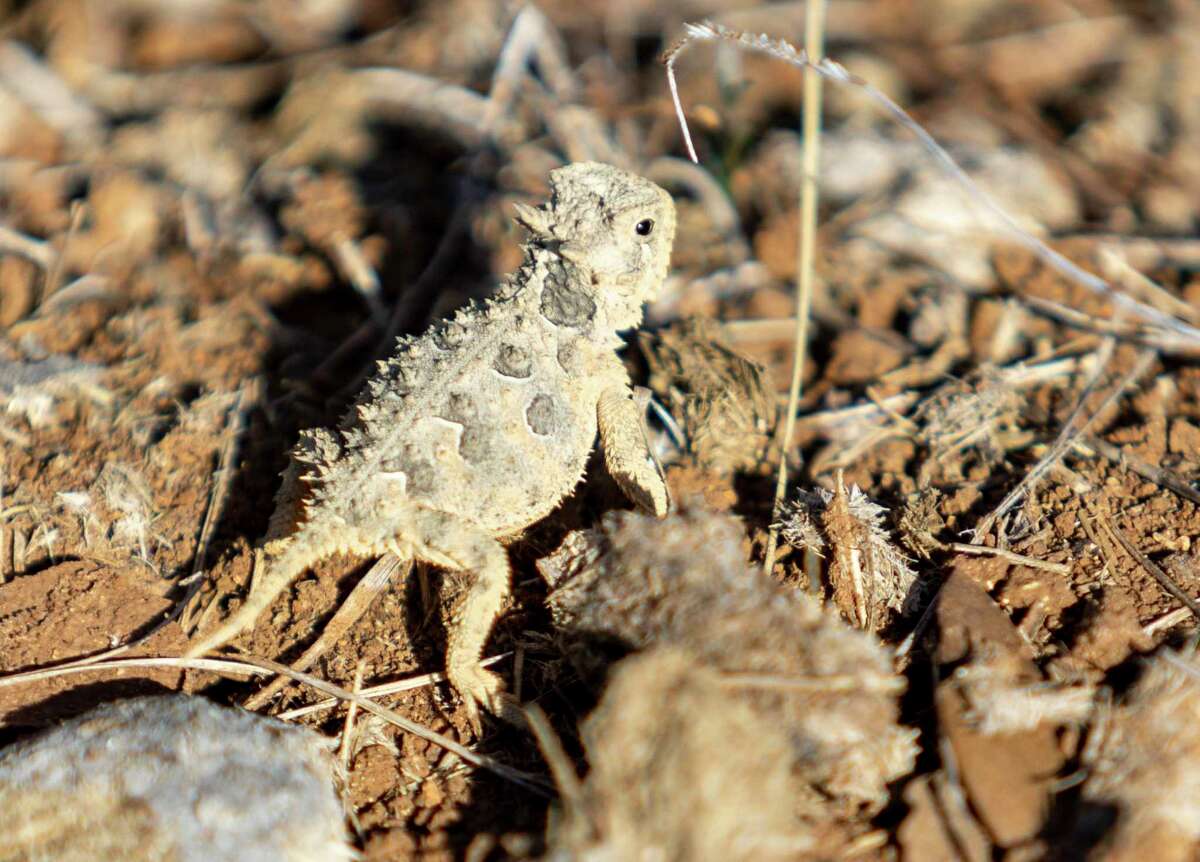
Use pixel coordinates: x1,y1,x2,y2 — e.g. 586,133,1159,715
762,0,826,574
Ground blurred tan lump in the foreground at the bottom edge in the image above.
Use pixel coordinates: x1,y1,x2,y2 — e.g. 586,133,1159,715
546,647,817,862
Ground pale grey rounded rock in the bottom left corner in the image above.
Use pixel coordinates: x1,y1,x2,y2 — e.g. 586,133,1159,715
0,695,354,862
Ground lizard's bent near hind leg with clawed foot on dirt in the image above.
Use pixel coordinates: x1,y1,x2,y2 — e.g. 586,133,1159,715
404,510,523,731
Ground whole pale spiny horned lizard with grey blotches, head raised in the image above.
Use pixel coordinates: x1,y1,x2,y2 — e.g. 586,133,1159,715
188,162,676,724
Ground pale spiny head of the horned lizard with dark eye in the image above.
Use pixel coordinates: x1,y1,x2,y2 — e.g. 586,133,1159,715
517,162,676,328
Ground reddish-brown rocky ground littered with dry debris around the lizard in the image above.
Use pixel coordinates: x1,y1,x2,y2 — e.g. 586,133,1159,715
0,0,1200,860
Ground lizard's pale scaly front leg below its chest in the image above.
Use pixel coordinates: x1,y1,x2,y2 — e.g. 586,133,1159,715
596,383,671,517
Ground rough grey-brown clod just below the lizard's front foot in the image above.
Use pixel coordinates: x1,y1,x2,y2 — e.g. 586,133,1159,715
539,511,917,808
